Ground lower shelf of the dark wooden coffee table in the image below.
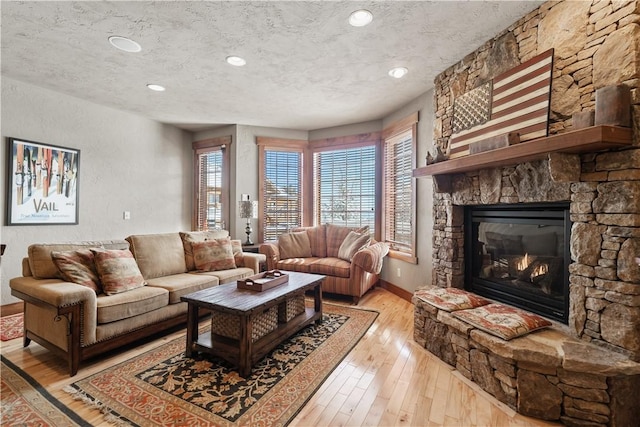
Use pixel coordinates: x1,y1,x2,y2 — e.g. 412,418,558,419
192,307,322,377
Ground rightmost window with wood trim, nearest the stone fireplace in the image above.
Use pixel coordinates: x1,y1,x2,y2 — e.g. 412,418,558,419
383,114,417,257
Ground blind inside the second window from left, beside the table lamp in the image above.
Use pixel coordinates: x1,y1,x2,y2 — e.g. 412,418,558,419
262,149,302,241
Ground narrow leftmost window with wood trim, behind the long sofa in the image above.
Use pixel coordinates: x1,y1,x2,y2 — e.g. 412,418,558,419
193,137,231,231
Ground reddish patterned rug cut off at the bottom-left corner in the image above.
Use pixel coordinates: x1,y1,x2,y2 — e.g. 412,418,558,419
0,356,91,427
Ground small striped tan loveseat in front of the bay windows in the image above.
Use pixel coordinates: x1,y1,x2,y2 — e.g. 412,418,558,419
260,224,389,304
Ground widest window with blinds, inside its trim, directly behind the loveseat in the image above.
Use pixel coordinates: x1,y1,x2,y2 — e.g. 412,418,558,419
314,145,376,234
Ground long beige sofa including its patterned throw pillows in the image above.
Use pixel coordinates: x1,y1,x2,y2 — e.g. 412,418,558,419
10,230,263,375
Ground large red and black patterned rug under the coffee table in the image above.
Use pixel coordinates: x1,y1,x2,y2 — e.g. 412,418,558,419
65,303,378,426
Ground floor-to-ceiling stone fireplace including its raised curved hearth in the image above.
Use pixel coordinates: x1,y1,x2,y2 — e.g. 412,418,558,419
414,0,640,426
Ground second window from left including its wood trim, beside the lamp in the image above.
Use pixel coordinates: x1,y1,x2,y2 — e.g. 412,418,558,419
258,137,306,242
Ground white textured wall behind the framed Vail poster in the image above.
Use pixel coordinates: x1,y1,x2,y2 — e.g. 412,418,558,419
0,77,192,304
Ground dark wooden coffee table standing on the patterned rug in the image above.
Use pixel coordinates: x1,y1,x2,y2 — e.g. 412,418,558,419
180,272,325,377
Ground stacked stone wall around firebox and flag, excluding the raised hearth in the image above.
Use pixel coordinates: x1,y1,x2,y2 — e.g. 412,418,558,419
432,0,640,361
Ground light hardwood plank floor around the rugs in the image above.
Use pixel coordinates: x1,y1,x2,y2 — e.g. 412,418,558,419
0,288,556,427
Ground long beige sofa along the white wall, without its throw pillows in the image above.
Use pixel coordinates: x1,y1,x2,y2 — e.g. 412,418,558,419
10,230,264,375
